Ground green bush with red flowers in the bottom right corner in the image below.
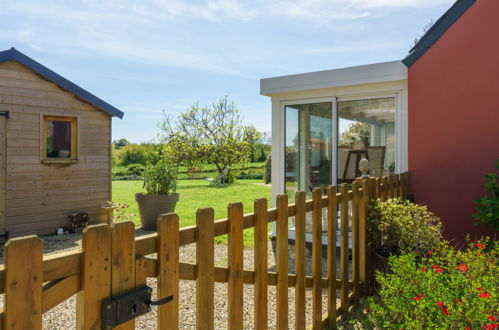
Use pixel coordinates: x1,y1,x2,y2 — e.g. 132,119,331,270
361,239,499,330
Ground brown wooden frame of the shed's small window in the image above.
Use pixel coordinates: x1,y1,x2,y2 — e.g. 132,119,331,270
40,114,78,164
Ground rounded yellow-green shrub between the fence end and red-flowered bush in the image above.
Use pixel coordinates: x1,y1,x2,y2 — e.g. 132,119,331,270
371,199,442,256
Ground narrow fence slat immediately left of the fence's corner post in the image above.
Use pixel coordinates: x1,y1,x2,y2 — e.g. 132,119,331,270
352,180,360,308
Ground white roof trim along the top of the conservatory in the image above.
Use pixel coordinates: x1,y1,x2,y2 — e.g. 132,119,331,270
260,61,407,96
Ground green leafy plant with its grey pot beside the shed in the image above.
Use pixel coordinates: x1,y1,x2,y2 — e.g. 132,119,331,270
135,161,179,230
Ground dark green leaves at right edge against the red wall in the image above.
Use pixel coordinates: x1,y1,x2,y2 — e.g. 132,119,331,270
473,160,499,230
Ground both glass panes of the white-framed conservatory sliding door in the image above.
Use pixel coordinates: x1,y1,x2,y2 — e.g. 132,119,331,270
284,97,396,193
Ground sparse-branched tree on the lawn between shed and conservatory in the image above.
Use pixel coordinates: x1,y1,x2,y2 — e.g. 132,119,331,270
159,97,260,173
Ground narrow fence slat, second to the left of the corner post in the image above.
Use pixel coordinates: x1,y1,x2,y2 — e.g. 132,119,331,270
340,183,349,317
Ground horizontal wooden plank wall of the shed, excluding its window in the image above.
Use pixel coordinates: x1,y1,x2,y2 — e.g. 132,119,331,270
0,62,111,236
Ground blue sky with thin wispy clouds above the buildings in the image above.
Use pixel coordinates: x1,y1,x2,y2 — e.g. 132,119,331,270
0,0,453,142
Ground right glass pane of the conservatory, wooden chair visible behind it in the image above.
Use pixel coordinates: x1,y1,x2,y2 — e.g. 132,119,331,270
338,97,395,183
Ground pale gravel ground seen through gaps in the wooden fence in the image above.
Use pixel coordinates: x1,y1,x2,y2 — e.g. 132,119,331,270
0,229,352,329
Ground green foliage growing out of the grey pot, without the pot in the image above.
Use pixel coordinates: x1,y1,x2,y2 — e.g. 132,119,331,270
143,161,177,195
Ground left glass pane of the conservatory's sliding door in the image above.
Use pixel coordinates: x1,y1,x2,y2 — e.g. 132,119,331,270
285,102,332,197
